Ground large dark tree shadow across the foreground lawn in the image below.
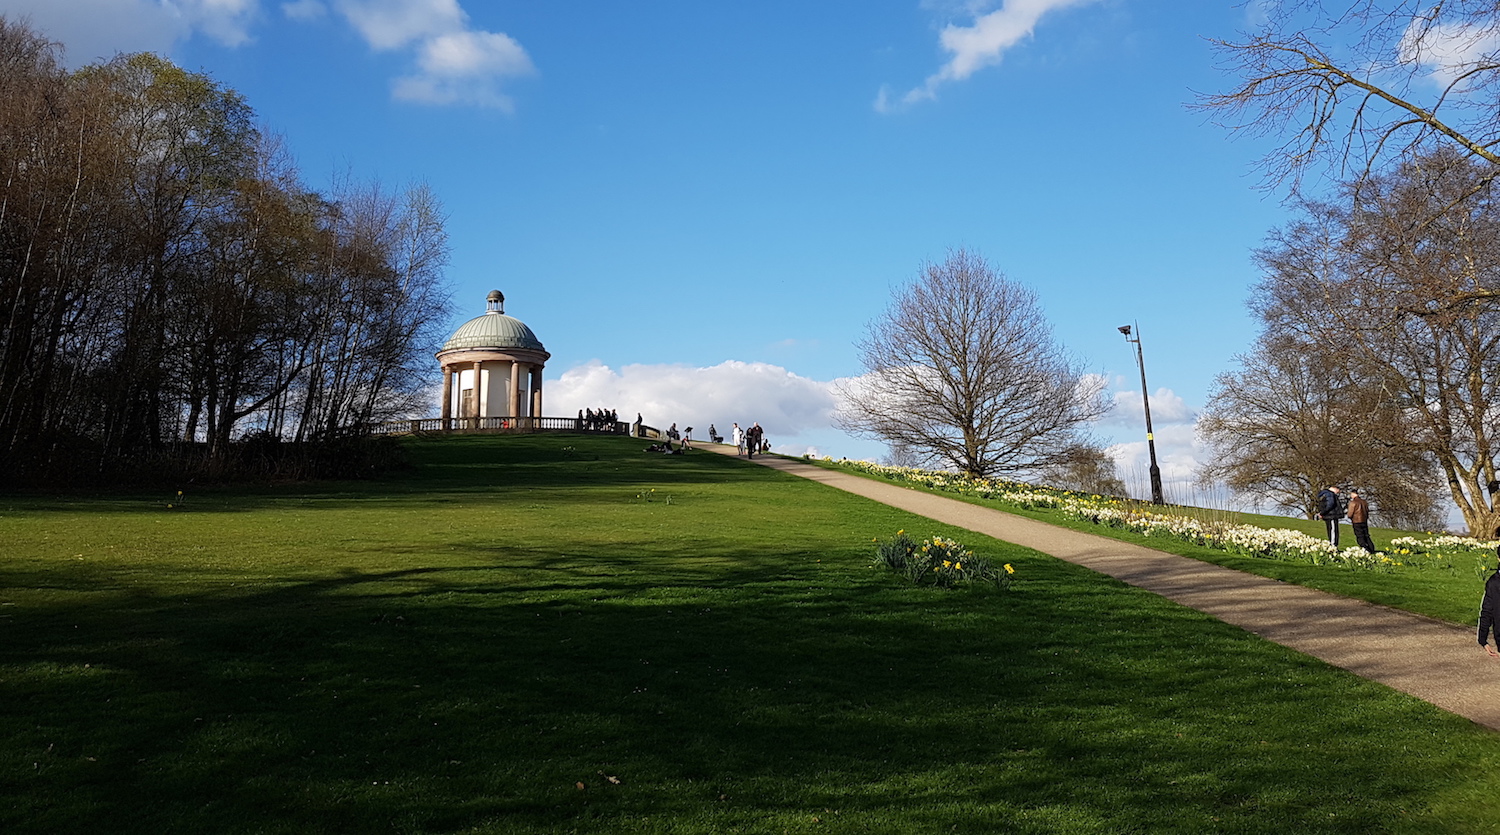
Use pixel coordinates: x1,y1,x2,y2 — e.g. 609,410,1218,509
0,549,1494,832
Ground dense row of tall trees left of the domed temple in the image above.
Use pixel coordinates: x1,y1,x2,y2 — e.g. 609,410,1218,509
0,18,447,481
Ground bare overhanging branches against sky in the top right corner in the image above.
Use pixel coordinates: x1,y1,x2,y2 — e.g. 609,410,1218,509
1200,0,1500,189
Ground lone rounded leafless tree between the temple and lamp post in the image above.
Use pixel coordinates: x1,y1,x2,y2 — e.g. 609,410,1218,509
840,249,1107,475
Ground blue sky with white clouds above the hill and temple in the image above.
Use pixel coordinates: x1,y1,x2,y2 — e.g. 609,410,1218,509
11,0,1286,498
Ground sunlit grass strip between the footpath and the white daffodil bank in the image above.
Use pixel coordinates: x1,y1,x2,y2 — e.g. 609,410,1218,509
809,459,1496,627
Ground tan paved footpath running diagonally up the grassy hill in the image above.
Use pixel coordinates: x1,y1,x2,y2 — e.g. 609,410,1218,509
701,444,1500,730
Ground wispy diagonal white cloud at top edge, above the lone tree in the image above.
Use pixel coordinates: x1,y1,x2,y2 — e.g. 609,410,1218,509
875,0,1094,112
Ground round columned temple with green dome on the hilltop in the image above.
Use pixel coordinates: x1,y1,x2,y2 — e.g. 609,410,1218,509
437,289,552,429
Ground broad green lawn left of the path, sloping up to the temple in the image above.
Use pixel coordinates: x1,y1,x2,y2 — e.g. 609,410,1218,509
0,436,1500,834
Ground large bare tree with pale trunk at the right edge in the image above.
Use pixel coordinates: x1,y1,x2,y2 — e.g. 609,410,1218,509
1226,150,1500,531
